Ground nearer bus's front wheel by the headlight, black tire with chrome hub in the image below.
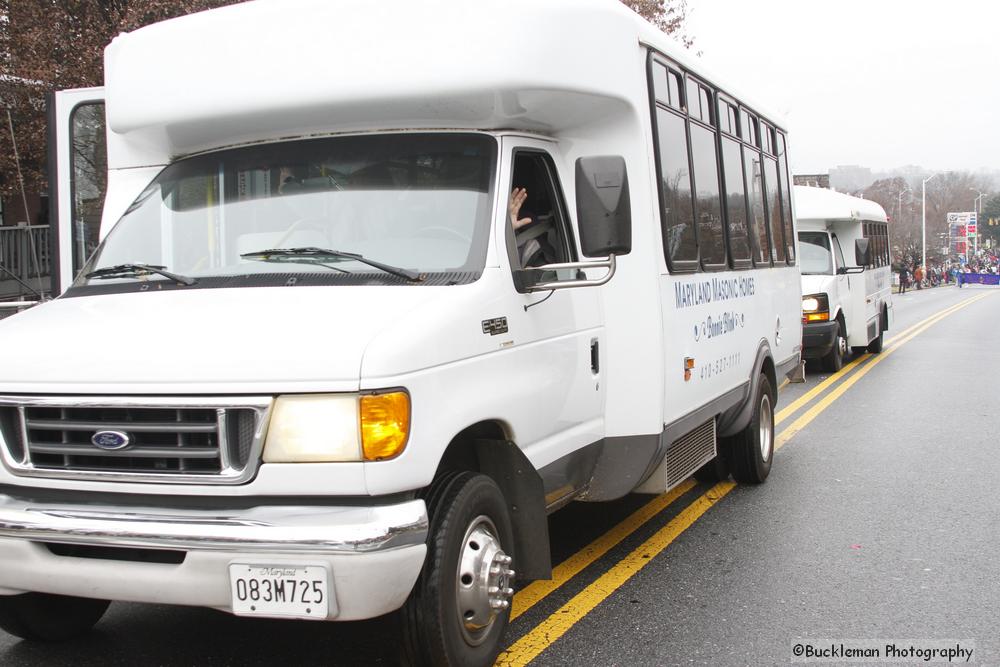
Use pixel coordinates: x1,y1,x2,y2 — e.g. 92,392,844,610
400,472,514,667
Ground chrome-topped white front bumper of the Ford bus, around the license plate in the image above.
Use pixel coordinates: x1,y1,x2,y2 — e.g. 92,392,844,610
0,495,428,620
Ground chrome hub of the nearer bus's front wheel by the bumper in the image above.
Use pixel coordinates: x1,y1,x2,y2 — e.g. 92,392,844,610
455,516,514,646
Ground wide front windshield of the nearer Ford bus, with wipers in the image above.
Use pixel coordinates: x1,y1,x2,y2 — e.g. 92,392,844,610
76,133,497,286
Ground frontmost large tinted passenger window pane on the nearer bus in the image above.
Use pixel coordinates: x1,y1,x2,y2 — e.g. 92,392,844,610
656,109,698,270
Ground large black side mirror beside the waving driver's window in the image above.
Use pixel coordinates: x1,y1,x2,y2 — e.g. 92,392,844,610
576,155,632,257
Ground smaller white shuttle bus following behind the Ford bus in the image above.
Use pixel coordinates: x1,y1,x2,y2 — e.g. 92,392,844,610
794,185,892,371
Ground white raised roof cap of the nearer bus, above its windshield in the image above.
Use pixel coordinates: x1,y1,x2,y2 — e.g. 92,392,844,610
105,0,781,167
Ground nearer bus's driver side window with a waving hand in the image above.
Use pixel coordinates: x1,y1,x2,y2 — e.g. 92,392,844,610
509,150,575,269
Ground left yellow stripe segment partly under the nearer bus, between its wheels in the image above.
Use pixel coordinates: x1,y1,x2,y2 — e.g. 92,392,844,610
510,479,695,621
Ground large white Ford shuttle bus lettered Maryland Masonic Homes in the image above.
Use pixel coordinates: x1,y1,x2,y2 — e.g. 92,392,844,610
0,0,802,665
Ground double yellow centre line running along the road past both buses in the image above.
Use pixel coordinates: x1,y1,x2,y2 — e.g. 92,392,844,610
496,294,990,667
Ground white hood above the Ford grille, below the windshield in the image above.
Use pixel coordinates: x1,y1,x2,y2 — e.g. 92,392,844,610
0,286,448,394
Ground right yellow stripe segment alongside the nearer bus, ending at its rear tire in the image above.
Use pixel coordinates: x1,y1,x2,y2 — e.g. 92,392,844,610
496,482,736,667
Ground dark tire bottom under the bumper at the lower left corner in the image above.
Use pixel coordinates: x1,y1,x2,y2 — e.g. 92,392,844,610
0,593,111,642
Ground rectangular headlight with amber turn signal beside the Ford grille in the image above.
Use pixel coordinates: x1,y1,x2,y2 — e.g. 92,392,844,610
264,391,410,463
